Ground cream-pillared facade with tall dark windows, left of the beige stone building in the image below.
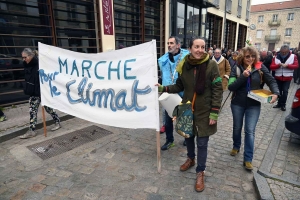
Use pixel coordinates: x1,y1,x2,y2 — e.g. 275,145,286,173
205,0,251,50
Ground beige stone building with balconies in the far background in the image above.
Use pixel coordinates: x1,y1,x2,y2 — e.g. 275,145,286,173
249,0,300,51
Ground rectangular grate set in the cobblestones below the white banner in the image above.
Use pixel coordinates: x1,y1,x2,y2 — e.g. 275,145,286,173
27,125,112,160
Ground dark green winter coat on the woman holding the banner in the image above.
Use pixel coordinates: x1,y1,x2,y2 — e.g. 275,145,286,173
167,54,223,137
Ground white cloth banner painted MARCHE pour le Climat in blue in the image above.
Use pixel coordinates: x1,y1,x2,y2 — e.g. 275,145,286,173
39,40,159,131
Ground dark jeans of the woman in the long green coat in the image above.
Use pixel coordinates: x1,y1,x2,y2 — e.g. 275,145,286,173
185,136,209,173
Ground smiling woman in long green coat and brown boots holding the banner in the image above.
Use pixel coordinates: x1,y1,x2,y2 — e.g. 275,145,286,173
157,37,223,192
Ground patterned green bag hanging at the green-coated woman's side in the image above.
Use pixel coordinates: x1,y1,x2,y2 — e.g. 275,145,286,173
173,93,196,138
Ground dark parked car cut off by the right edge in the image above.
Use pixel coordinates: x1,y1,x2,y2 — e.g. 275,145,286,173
285,88,300,135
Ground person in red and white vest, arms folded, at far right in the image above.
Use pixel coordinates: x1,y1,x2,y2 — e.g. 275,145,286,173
270,45,299,111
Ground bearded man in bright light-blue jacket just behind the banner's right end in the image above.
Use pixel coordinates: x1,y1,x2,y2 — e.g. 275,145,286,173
158,36,189,150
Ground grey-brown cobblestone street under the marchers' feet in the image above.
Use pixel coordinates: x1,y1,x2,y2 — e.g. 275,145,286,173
0,83,300,200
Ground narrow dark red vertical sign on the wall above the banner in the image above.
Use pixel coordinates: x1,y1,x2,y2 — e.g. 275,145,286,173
102,0,114,35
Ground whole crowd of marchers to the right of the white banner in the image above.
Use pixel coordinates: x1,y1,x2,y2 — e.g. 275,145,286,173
156,36,300,192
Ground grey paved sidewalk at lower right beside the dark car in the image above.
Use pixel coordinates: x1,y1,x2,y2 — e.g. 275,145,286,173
254,84,300,199
